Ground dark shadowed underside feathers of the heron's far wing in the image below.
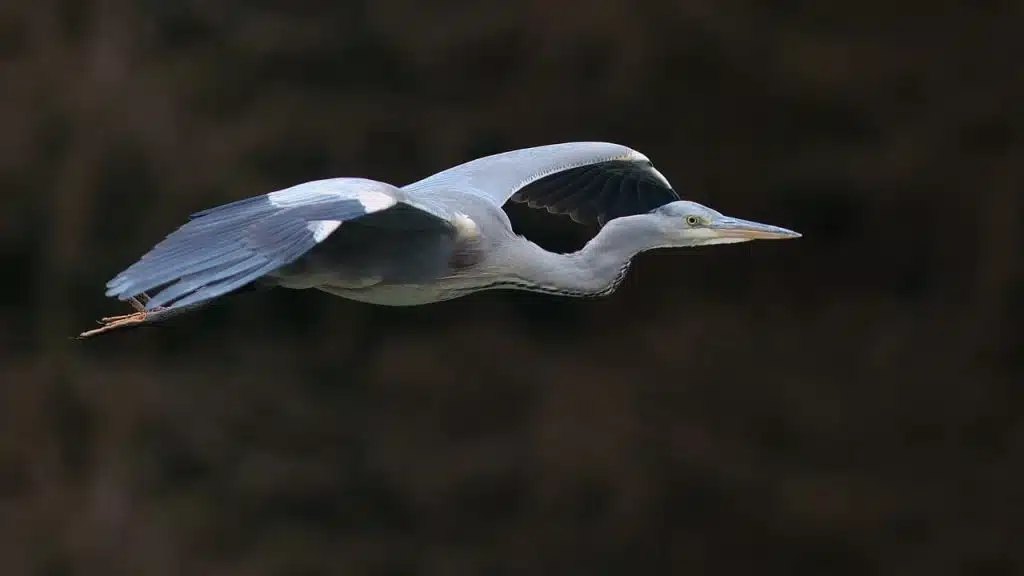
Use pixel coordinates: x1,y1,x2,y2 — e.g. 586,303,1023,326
511,160,679,225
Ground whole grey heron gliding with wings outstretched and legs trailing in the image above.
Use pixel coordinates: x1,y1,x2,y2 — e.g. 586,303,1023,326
79,141,801,337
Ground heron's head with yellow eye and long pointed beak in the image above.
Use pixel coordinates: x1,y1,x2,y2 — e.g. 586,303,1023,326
652,200,801,246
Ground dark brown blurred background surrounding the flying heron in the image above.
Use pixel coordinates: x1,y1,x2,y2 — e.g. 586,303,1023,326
0,0,1024,576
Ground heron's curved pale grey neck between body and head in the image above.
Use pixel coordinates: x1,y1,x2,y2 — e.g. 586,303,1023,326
507,214,665,297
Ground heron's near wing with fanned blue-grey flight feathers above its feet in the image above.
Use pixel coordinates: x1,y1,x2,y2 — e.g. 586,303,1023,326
106,178,453,311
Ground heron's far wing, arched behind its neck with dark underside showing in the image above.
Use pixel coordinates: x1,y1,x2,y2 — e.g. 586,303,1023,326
402,142,679,225
